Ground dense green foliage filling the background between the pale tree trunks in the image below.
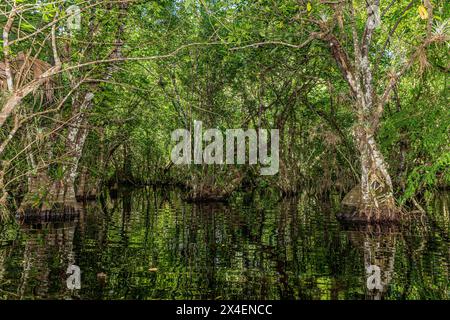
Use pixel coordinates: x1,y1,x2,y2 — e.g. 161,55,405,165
0,0,450,212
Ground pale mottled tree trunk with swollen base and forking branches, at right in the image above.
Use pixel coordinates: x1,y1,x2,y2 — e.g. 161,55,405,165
317,0,408,222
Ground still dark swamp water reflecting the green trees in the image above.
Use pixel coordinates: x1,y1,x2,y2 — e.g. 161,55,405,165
0,188,450,299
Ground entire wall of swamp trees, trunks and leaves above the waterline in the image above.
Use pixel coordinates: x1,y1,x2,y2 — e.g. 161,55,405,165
0,0,450,220
